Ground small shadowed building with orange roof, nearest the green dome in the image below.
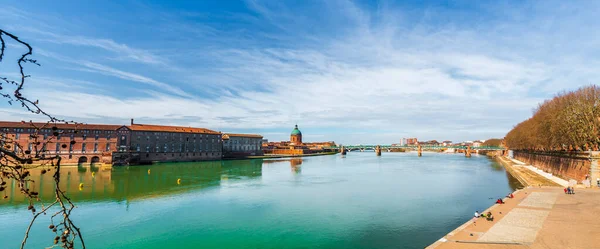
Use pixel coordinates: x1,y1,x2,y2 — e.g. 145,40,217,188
222,133,263,157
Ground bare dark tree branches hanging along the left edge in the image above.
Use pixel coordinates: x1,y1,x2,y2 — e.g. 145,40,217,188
0,29,85,248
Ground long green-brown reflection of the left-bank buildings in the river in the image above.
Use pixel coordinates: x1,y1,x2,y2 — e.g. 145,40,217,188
0,159,263,205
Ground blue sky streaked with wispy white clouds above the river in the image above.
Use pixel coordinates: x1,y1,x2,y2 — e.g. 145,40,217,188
0,0,600,144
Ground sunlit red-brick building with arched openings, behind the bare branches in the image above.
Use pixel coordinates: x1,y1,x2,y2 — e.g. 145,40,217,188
0,122,120,165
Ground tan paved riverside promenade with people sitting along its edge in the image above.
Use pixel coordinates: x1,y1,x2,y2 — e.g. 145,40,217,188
428,187,600,249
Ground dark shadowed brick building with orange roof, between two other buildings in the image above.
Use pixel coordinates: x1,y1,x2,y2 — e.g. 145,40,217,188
113,119,222,164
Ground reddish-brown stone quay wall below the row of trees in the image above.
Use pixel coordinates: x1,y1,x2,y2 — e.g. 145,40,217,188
513,151,600,185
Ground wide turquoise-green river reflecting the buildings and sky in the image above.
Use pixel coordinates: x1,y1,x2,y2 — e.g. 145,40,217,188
0,152,520,249
